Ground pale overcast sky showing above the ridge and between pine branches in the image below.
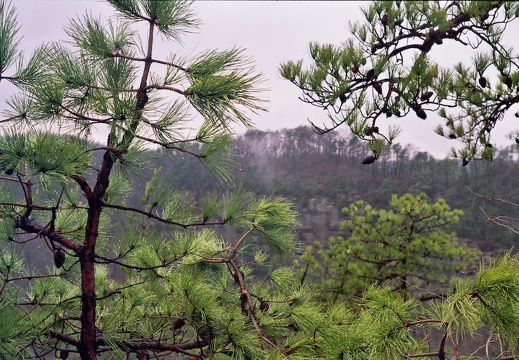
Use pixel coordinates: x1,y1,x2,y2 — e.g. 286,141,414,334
4,0,519,158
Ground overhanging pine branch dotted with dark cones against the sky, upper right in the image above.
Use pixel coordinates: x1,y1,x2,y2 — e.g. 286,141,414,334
280,1,519,162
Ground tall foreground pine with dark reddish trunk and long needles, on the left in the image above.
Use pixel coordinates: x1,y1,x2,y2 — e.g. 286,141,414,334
0,0,304,359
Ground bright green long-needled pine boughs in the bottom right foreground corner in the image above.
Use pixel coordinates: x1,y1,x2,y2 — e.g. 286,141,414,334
304,255,518,359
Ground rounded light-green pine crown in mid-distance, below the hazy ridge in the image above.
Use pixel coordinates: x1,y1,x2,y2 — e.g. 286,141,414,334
303,193,480,301
